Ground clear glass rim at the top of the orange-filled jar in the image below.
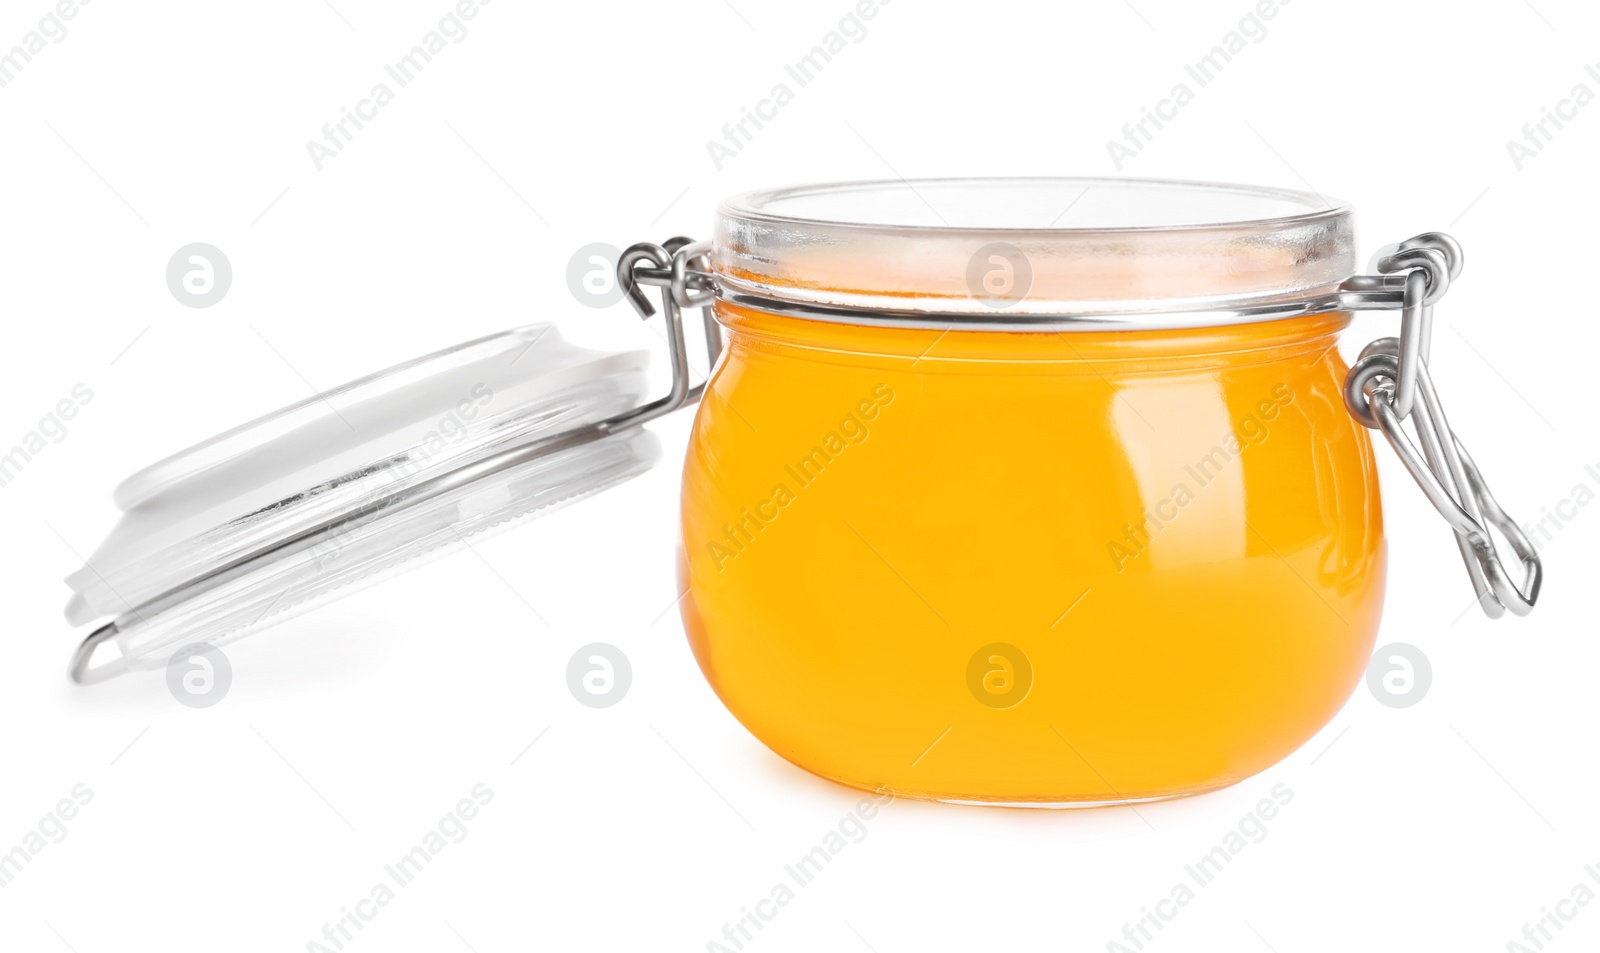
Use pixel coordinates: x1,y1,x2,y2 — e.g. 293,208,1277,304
710,177,1355,329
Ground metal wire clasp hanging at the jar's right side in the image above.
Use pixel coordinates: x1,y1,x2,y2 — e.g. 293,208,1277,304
1342,232,1542,619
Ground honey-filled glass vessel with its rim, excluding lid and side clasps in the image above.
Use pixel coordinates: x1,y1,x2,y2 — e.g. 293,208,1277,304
680,179,1386,806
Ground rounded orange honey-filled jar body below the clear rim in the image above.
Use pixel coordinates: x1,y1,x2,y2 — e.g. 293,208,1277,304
678,304,1384,804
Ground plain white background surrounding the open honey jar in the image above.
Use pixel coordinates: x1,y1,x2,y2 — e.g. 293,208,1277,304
0,0,1600,953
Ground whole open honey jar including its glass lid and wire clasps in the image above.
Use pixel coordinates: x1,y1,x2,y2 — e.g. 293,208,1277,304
67,179,1541,806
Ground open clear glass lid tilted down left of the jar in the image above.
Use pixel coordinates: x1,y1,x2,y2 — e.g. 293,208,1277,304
67,325,659,681
